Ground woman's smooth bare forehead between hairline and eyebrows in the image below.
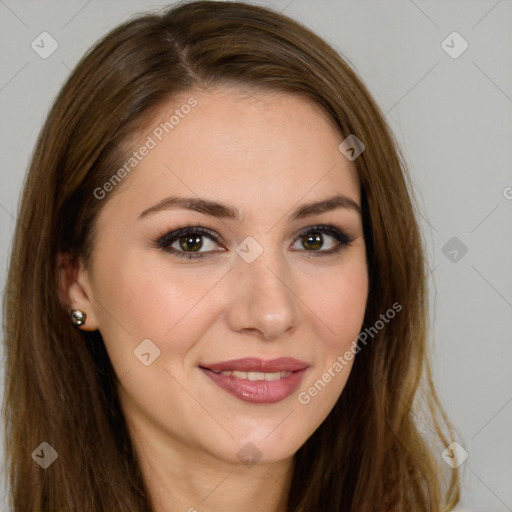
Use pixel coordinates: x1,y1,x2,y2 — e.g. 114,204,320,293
96,88,360,223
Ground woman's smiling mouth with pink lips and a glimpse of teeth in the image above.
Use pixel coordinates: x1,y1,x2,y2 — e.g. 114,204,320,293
199,357,309,404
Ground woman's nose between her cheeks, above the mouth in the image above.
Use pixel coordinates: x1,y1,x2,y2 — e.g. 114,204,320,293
227,247,299,341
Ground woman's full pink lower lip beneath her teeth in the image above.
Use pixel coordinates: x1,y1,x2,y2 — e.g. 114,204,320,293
201,368,306,404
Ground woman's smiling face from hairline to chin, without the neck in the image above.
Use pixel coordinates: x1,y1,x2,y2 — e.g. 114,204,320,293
75,89,368,464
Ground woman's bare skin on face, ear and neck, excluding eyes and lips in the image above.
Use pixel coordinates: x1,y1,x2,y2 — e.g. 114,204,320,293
62,88,368,512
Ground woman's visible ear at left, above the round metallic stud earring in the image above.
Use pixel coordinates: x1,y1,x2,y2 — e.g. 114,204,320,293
57,253,99,331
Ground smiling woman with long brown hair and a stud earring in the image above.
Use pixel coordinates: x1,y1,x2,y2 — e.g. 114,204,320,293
4,2,459,512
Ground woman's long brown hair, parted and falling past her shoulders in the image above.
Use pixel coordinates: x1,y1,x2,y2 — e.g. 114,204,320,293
4,1,459,512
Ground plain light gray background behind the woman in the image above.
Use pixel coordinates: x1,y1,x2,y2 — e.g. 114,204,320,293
0,0,512,512
